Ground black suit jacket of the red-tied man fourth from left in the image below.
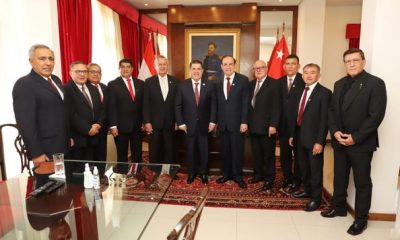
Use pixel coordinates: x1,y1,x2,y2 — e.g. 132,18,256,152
107,77,144,133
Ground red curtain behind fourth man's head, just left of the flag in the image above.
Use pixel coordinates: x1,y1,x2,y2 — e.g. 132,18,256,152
119,15,140,77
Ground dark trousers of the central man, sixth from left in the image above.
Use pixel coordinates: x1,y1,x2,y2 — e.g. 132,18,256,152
186,131,208,176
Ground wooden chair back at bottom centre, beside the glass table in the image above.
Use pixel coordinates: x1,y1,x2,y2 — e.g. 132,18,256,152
167,187,209,240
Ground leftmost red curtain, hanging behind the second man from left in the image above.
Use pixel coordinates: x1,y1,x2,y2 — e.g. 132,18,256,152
57,0,92,83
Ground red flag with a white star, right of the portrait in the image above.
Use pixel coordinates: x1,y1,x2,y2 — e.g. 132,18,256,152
267,35,289,79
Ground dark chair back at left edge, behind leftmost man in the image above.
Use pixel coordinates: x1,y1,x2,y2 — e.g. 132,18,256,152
0,124,32,180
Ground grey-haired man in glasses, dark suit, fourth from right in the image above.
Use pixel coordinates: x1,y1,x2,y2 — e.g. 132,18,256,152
249,60,281,190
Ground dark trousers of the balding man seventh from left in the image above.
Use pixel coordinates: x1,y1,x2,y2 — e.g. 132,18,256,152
220,131,244,181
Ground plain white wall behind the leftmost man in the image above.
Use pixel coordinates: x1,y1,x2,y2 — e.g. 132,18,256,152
0,0,61,177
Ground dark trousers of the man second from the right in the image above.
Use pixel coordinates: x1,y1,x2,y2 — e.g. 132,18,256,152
296,137,324,202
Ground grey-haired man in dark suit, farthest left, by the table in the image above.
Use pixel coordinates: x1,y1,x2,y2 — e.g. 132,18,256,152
12,44,69,166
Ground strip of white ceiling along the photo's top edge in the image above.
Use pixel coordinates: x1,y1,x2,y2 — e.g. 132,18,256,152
124,0,362,9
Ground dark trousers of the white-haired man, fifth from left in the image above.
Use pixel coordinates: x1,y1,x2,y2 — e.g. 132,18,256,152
150,129,174,164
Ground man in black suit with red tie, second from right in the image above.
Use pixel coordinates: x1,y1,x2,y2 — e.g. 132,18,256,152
289,63,332,212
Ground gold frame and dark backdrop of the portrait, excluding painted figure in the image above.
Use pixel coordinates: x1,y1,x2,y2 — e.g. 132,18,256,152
185,28,240,78
